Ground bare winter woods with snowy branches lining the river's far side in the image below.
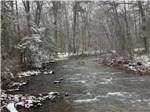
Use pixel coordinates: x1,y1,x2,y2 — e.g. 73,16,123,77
1,1,150,79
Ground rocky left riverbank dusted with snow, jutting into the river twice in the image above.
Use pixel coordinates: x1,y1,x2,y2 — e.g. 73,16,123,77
1,70,60,112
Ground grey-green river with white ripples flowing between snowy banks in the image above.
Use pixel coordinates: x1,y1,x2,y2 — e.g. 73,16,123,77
15,58,150,112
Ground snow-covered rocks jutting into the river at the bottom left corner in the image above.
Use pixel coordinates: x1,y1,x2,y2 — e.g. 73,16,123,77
1,92,59,112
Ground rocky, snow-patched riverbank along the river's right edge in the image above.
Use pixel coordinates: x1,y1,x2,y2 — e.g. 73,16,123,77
98,54,150,75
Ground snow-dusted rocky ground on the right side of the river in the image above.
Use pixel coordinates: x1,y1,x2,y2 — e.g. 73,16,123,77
108,54,150,74
